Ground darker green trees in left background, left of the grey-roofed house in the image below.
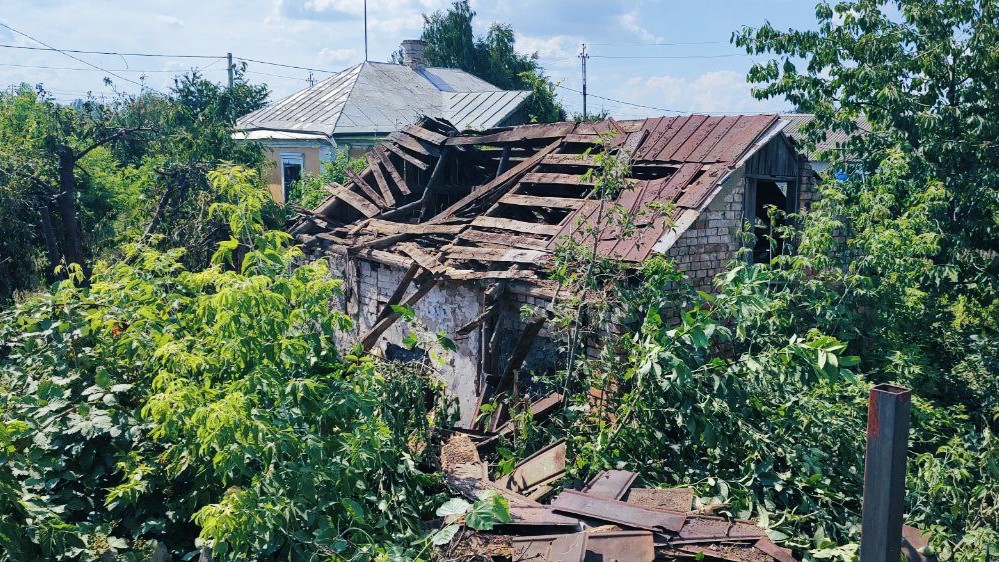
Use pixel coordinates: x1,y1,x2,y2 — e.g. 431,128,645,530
0,71,267,302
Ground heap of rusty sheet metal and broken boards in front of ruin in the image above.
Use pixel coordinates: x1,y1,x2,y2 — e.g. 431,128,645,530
441,433,794,562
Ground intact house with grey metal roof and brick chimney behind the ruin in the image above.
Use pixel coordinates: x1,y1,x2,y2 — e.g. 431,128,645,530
235,40,530,203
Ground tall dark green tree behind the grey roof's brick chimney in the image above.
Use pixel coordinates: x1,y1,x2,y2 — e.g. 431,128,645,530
392,0,566,123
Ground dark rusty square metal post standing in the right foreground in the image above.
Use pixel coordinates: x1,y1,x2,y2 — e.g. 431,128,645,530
860,384,912,562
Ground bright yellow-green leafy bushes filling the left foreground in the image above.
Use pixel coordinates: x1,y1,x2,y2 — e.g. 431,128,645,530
0,167,448,560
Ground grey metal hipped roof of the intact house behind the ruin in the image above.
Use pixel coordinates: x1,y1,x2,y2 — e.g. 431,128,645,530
236,62,530,137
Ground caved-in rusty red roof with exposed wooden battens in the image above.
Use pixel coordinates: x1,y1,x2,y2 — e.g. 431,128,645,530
291,115,785,280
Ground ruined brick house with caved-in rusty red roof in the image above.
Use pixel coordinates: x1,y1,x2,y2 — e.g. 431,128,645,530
290,115,813,424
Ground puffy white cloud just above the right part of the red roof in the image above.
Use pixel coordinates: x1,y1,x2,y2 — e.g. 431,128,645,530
617,70,790,113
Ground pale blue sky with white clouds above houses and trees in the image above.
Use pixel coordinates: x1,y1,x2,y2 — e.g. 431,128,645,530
0,0,816,118
